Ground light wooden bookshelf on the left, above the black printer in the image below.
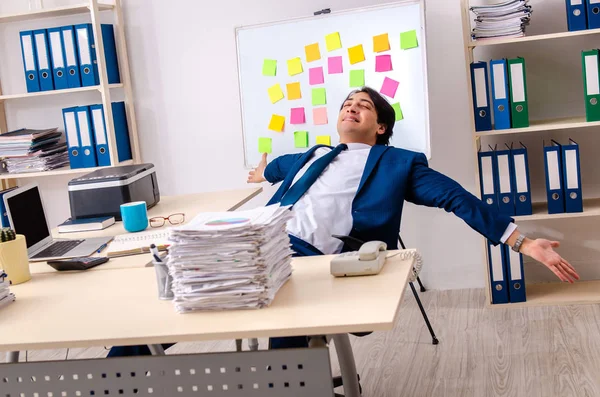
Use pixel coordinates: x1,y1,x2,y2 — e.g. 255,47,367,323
0,0,141,188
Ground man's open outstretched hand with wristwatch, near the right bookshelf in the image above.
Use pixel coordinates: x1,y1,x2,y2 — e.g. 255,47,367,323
506,230,579,283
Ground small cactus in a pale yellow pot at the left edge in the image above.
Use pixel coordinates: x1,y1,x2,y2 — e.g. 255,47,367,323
0,227,31,285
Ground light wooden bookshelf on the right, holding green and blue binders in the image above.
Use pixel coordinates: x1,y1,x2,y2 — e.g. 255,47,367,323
461,0,600,308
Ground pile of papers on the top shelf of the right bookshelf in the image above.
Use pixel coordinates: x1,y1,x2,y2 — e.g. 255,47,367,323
471,0,531,40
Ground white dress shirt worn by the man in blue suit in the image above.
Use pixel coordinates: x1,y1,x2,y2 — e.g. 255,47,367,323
287,143,517,254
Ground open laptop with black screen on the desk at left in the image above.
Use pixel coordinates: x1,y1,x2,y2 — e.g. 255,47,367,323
4,183,112,262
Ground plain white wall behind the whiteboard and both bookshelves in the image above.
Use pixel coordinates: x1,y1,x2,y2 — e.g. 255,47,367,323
0,0,600,289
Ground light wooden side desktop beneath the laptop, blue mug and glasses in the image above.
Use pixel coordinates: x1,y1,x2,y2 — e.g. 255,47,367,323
29,187,263,274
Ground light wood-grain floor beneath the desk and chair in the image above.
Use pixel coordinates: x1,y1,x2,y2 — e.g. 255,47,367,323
1,290,600,397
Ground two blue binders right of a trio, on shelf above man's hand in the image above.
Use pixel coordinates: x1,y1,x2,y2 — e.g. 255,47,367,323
544,139,583,214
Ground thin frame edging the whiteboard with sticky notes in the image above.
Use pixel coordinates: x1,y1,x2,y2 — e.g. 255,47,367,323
234,0,431,170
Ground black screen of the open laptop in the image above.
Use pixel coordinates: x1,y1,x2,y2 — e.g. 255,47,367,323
6,186,50,248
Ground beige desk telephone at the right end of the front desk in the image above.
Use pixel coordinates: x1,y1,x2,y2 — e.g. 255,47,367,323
330,241,387,277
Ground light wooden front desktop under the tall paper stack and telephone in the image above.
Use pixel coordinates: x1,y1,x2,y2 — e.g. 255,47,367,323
0,251,413,351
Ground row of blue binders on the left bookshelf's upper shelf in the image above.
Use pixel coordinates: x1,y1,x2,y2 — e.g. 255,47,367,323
20,23,121,92
